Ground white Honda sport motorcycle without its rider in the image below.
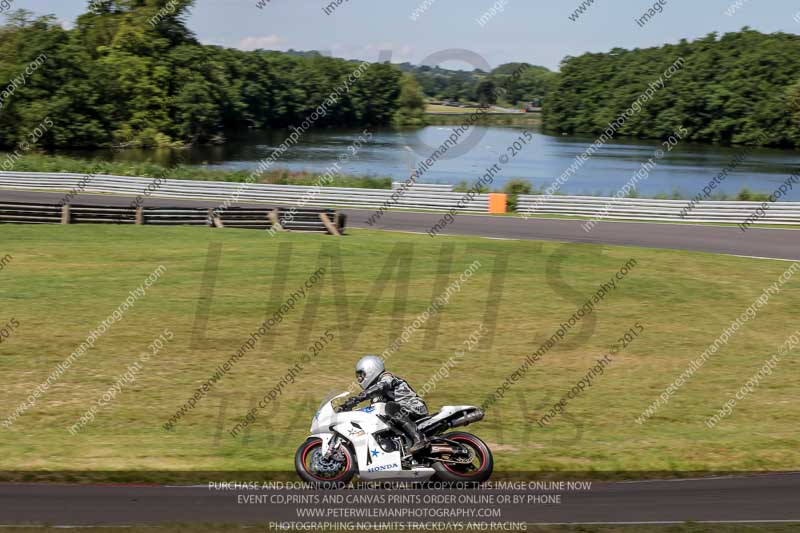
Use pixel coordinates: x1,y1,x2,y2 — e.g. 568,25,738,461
294,392,494,485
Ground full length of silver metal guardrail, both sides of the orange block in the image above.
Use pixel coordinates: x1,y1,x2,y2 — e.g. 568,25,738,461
0,172,800,225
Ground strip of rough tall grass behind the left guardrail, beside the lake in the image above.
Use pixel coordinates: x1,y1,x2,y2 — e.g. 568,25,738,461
5,154,392,189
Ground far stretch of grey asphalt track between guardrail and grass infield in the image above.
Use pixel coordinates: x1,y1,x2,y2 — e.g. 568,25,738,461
0,190,800,260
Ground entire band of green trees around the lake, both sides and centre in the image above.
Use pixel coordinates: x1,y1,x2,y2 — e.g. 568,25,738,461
0,0,800,148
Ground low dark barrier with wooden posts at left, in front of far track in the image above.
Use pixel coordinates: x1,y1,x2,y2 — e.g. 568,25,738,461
0,202,346,235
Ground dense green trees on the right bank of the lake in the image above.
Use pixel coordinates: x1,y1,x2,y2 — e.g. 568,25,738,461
543,28,800,147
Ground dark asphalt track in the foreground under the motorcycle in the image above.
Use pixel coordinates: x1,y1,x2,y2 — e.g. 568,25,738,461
0,474,800,525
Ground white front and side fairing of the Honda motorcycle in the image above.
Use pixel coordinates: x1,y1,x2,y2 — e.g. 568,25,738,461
311,392,434,481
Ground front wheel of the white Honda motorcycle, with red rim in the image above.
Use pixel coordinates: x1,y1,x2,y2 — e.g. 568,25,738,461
294,438,356,487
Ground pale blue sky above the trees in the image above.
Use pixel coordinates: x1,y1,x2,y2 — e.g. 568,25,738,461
14,0,800,69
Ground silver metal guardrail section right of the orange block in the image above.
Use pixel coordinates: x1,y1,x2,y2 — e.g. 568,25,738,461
517,195,800,225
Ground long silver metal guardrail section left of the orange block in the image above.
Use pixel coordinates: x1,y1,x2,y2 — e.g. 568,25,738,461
0,172,489,213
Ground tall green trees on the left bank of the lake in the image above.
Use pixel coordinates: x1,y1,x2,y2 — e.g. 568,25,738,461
0,0,412,148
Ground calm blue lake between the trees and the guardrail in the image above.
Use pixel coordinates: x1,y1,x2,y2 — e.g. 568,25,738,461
60,126,800,201
